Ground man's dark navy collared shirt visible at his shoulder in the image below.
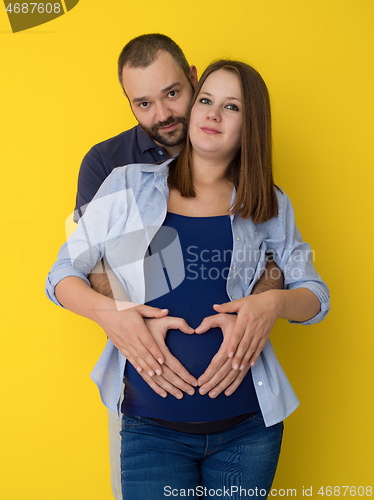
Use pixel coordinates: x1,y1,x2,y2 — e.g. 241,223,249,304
74,125,169,222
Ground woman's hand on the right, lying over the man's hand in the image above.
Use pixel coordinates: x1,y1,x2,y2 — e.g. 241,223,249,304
213,290,279,371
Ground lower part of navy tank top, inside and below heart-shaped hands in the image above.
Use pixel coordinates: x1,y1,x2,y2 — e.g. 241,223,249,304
122,328,258,422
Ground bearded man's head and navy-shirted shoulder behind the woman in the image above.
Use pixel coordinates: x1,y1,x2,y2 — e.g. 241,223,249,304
76,34,197,219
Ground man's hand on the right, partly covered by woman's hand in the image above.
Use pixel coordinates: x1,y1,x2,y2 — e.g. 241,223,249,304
195,314,249,398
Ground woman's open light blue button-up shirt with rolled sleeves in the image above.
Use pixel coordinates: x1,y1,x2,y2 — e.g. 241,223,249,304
46,160,329,426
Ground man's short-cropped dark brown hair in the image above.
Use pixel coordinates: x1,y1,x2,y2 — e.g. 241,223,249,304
118,33,191,87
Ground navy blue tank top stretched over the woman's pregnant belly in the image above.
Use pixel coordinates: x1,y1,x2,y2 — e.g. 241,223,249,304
122,213,259,422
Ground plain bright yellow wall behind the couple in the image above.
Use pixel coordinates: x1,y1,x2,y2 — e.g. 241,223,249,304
0,0,374,500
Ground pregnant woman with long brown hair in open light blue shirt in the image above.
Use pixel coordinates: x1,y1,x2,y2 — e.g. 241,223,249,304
48,61,328,500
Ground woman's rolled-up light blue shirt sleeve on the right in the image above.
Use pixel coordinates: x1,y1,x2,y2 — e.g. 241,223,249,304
266,189,330,325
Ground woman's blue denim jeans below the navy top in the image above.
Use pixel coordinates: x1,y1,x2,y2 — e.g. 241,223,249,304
121,412,283,500
